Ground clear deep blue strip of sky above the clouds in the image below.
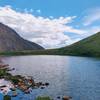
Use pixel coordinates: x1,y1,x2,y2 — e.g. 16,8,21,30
0,0,100,17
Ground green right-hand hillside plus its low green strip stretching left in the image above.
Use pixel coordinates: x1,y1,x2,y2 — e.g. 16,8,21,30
0,32,100,57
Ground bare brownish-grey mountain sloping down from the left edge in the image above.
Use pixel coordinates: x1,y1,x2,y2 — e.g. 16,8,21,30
0,23,44,52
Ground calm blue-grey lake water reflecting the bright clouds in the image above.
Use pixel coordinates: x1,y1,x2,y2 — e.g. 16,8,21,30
1,55,100,100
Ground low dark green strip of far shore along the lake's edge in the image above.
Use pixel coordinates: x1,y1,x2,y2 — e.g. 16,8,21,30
0,49,100,58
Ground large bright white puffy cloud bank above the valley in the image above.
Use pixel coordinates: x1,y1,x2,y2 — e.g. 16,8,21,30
0,6,85,48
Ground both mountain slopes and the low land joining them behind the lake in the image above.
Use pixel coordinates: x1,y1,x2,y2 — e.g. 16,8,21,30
0,23,100,57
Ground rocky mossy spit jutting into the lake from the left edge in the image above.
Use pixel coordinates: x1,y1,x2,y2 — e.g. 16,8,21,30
0,64,49,97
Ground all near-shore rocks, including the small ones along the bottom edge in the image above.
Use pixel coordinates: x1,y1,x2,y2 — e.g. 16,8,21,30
0,64,72,100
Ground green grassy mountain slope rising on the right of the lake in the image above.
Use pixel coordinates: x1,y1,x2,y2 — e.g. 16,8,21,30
58,32,100,57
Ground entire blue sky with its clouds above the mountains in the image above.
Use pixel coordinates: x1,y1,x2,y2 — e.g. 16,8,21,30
0,0,100,48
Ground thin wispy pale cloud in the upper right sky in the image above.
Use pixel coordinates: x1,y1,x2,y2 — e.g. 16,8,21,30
84,8,100,26
